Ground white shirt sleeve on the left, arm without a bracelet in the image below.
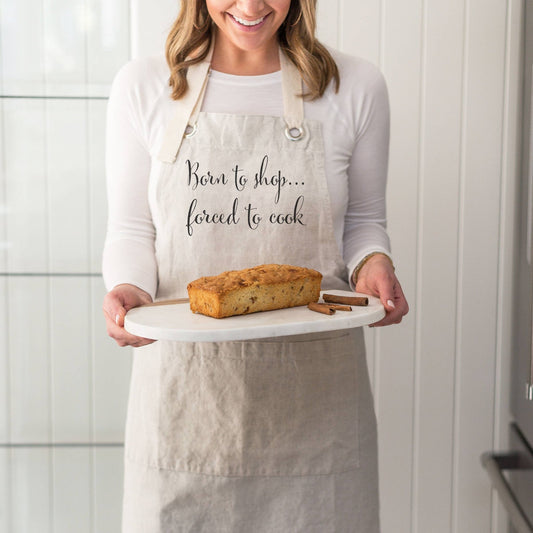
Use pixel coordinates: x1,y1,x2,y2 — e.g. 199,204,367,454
102,63,157,298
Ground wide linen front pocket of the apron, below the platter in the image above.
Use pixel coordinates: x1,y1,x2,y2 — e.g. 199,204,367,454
152,330,364,476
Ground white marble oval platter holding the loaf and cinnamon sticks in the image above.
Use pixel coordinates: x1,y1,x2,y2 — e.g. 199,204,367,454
124,290,385,342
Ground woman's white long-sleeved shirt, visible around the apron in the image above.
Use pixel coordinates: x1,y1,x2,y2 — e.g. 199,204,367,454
103,47,390,297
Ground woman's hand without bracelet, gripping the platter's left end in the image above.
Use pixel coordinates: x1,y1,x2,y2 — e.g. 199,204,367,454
103,284,155,348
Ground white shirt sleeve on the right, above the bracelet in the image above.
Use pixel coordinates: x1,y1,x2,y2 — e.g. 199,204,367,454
343,62,391,289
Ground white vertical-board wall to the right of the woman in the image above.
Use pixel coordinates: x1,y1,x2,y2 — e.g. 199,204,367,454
320,0,522,533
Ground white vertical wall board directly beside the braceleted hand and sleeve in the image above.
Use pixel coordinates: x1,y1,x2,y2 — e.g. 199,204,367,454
376,0,422,531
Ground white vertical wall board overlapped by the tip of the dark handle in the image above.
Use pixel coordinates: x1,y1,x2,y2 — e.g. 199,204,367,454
454,0,507,533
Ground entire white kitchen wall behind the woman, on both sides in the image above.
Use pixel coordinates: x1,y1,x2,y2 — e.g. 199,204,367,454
0,0,522,533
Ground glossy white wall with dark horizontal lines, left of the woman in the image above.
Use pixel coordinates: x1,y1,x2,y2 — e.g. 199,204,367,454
0,0,130,533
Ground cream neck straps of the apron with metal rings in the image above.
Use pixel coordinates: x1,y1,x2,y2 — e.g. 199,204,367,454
159,44,304,163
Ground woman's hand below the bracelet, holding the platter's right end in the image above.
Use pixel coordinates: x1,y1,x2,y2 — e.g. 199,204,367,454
355,254,409,326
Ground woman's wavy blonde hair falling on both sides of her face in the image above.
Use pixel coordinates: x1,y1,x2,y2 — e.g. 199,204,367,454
166,0,340,100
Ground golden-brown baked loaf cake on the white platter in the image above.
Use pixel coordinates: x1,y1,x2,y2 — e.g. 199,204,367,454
187,265,322,318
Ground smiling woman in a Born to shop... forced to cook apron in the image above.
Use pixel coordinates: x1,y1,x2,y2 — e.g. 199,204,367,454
104,0,408,533
